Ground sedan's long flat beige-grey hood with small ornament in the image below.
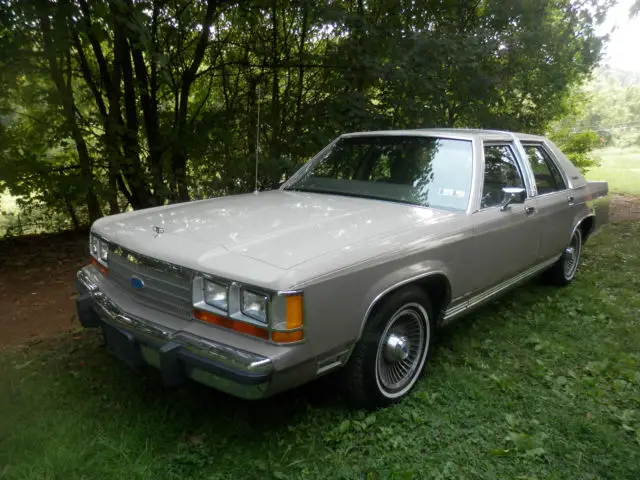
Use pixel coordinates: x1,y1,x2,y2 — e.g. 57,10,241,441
94,190,454,270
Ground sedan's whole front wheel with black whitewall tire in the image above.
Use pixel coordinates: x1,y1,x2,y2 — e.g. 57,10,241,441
343,287,433,408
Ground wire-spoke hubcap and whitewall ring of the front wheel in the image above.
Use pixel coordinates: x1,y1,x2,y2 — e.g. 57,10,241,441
376,304,430,397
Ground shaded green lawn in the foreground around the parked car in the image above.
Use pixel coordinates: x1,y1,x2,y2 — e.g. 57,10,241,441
0,223,640,480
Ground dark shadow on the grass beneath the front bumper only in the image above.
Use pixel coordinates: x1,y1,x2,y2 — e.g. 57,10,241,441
39,331,344,436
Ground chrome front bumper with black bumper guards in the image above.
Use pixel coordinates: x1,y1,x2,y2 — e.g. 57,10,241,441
76,266,273,399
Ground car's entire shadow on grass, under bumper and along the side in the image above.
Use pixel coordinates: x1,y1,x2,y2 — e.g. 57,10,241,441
42,274,555,433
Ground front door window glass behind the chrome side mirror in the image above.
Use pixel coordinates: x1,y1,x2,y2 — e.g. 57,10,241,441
480,145,524,208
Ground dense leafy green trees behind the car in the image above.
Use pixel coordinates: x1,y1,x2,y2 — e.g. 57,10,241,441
0,0,611,232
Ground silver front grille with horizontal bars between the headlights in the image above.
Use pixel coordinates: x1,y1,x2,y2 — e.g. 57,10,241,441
109,246,193,319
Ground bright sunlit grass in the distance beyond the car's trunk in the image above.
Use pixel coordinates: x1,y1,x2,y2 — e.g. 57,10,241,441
587,147,640,195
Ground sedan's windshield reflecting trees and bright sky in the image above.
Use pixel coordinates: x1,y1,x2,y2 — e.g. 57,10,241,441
285,135,473,210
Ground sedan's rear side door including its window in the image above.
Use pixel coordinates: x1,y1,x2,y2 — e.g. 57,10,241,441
523,143,576,260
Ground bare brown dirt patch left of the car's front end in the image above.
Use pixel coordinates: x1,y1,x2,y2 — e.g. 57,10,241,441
0,233,88,346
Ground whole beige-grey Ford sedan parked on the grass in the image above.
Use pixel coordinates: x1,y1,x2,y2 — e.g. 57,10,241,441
77,129,608,407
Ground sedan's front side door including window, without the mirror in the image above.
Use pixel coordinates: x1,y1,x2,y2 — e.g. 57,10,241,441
472,143,539,291
